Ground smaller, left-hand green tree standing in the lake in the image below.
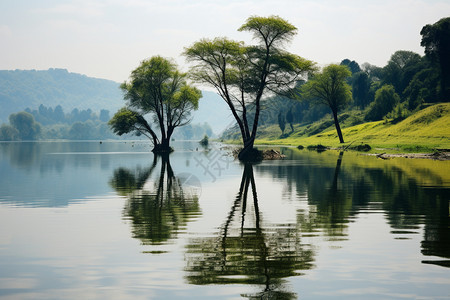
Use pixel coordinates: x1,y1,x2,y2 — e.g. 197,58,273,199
109,56,202,153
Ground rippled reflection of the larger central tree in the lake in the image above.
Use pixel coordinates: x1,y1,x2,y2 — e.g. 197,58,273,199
185,164,314,299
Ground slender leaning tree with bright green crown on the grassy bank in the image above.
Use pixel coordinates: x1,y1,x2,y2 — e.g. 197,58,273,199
303,65,352,143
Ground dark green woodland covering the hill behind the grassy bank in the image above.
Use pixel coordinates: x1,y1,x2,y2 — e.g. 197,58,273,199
224,18,450,150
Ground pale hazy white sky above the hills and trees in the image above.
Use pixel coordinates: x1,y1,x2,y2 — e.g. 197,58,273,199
0,0,450,82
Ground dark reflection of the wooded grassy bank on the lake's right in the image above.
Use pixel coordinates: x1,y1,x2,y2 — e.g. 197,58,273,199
256,149,450,267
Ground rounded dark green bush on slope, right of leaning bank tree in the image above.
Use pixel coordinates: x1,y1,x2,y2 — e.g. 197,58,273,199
365,85,400,121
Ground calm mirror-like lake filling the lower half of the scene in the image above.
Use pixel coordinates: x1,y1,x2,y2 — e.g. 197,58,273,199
0,141,450,299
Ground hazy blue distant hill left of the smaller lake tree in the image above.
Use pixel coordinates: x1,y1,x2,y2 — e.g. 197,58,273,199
0,69,123,123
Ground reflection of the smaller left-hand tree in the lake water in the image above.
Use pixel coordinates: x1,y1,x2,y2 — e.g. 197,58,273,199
110,155,201,245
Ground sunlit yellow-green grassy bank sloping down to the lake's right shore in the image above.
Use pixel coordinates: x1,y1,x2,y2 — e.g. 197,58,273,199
251,103,450,152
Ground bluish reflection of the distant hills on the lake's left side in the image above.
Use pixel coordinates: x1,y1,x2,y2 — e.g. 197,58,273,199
0,141,239,206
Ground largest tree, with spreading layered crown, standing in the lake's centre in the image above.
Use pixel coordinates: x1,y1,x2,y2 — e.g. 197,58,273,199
184,16,314,160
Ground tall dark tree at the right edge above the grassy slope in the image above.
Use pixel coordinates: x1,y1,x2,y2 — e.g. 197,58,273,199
420,17,450,101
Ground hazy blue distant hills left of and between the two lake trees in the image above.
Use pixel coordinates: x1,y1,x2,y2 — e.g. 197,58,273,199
0,69,232,134
